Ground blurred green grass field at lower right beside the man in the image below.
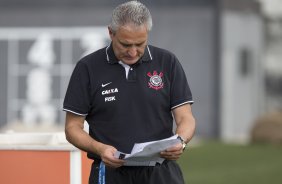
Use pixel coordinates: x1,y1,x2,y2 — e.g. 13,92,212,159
178,141,282,184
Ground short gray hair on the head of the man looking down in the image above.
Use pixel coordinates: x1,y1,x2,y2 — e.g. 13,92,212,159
109,1,153,33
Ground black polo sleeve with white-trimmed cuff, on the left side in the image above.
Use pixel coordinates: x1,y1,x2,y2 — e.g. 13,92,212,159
63,62,90,116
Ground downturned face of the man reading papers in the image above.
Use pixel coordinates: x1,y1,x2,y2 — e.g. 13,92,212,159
109,25,148,65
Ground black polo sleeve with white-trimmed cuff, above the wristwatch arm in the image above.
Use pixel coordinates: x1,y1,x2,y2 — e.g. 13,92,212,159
170,57,194,109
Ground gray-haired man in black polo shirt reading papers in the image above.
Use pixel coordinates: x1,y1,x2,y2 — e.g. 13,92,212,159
64,1,195,184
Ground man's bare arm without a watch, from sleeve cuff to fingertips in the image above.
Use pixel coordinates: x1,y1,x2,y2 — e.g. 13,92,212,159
65,112,124,168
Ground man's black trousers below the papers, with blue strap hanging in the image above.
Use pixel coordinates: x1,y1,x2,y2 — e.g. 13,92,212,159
89,160,184,184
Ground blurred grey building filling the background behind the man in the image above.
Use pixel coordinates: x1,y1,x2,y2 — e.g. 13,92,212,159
0,0,282,141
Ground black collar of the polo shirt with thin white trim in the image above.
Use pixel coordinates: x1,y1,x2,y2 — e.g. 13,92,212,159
106,43,153,64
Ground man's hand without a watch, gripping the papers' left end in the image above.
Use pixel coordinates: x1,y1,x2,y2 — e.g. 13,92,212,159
99,144,124,168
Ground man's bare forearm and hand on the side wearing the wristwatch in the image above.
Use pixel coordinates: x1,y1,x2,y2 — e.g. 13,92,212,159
161,104,196,160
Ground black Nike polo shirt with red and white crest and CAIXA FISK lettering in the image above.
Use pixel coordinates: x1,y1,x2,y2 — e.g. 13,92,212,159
63,45,193,158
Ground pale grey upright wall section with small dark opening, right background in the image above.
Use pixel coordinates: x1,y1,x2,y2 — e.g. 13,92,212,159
220,12,264,142
